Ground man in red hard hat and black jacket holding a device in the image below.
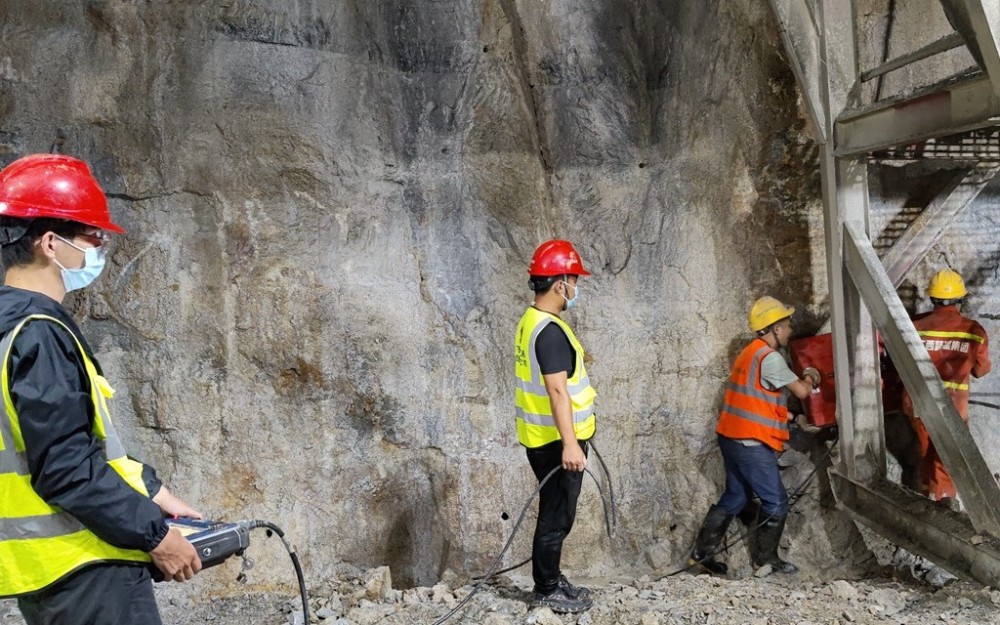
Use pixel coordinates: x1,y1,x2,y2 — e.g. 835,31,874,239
0,154,201,625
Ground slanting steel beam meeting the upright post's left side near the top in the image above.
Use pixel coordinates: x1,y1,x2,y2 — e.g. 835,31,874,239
770,0,830,144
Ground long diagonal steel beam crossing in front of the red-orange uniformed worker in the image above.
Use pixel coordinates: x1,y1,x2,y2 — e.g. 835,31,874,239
835,223,1000,537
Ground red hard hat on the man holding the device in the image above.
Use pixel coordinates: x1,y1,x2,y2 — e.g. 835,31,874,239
0,154,125,233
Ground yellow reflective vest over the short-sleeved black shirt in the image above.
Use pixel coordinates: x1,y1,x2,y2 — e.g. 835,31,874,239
514,307,597,448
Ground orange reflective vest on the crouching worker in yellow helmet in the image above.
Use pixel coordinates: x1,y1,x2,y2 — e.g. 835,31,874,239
715,339,788,451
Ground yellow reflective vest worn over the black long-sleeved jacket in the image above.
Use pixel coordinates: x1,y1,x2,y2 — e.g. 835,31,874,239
0,315,150,597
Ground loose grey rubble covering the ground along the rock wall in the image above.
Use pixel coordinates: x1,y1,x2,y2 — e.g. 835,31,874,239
0,567,1000,625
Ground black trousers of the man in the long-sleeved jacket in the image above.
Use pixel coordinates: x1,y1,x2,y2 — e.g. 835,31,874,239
17,563,163,625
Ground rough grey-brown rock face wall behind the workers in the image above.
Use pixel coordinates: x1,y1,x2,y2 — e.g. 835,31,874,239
7,0,988,585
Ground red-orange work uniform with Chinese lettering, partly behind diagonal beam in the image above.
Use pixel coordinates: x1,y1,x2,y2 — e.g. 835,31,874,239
903,306,991,499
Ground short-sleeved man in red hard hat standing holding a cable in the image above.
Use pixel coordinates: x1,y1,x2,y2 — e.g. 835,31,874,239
514,240,597,613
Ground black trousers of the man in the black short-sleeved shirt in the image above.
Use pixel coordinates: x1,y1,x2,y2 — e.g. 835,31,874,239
528,441,587,594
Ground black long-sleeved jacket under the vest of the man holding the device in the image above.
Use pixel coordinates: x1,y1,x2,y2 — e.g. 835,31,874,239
0,286,168,552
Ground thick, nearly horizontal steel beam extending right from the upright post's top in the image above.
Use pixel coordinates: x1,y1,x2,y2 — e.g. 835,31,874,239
833,77,1000,157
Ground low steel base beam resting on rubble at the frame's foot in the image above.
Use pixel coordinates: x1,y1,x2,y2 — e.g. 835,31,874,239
829,469,1000,586
